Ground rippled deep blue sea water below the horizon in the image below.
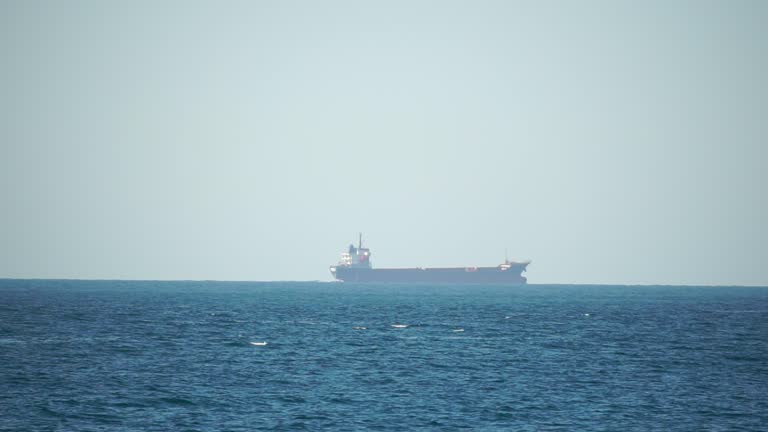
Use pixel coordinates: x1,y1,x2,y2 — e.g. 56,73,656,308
0,280,768,431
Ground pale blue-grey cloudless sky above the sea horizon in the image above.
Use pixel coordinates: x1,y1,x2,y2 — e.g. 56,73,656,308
0,0,768,286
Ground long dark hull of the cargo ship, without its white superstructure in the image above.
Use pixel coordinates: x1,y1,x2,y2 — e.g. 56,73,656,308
331,265,526,285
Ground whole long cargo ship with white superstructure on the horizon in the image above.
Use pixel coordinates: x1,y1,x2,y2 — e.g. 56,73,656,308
330,234,530,285
